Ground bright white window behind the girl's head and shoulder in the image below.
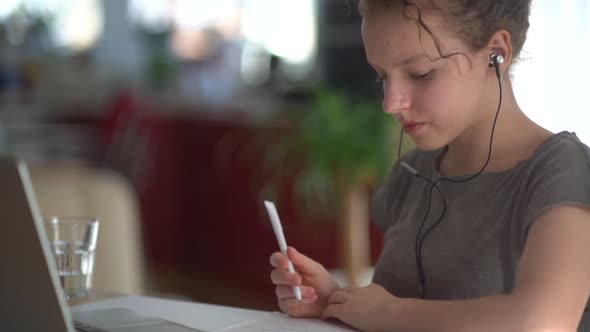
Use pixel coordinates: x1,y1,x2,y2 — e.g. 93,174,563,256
514,0,590,144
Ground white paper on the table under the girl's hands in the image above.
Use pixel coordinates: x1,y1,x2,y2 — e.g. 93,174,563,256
217,313,356,332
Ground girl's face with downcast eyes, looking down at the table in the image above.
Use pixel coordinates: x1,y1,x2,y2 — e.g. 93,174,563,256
362,9,495,150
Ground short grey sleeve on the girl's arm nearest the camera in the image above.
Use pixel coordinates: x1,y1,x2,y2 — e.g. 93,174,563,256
521,133,590,241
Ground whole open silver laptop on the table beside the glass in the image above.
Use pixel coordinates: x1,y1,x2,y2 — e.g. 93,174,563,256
0,156,204,332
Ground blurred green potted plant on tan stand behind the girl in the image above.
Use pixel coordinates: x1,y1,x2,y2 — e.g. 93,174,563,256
265,87,408,285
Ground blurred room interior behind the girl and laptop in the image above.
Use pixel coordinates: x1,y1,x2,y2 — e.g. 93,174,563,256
0,0,590,310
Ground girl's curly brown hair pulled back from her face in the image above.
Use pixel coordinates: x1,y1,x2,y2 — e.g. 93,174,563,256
359,0,531,58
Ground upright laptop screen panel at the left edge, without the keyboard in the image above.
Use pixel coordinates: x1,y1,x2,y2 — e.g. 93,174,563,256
0,157,73,331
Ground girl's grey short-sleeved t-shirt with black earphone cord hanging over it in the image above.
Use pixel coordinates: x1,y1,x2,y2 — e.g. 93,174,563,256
372,132,590,331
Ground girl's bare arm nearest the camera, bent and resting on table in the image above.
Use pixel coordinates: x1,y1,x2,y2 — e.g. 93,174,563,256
323,206,590,332
